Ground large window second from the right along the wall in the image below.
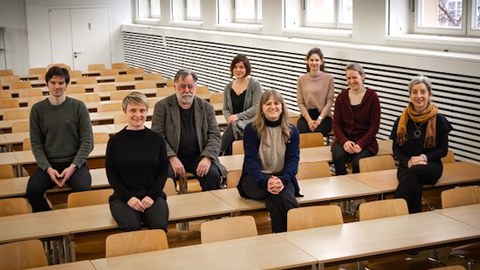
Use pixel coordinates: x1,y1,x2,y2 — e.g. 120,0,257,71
284,0,353,29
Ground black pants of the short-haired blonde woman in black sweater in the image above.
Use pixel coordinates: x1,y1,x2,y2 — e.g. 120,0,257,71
110,196,168,232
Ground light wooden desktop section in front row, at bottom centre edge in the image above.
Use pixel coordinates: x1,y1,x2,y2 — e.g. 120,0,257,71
92,234,321,270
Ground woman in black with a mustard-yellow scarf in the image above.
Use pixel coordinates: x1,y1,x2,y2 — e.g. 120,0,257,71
390,76,453,213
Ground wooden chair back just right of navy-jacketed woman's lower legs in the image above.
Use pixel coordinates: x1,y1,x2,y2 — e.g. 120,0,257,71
287,205,343,231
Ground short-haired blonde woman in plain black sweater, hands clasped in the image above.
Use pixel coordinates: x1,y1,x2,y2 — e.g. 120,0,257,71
105,92,168,232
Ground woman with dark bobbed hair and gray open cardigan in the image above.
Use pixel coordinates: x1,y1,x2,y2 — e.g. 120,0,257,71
220,54,262,155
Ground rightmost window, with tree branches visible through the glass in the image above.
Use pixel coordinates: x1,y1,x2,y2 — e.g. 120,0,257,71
415,0,480,36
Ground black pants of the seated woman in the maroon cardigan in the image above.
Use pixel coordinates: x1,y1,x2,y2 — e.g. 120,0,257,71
332,143,374,175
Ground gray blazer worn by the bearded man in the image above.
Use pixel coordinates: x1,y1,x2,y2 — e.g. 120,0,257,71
152,94,227,176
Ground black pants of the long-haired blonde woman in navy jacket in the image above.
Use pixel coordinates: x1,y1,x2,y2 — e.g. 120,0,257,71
240,175,298,233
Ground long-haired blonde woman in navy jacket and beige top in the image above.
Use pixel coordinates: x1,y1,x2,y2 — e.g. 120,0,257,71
237,90,301,233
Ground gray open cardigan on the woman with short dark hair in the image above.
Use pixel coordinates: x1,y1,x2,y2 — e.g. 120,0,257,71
223,78,263,140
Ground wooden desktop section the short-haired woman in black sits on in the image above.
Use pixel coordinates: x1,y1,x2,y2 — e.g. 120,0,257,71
53,192,235,234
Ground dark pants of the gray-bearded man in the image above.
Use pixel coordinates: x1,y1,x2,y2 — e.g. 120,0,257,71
168,157,222,191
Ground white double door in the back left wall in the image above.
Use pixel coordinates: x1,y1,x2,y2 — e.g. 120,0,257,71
49,8,112,71
